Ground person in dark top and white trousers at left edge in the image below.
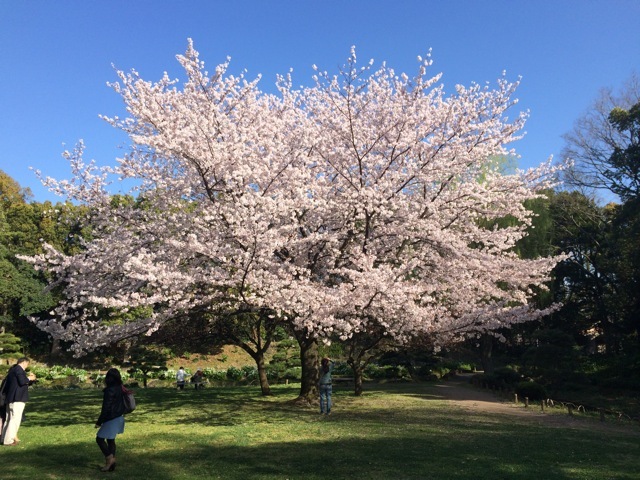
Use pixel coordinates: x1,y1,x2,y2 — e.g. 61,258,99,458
2,357,36,447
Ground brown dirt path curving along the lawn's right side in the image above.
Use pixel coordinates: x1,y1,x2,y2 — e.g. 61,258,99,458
436,375,640,436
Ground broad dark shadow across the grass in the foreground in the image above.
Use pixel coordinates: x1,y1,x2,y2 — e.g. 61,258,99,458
2,425,638,480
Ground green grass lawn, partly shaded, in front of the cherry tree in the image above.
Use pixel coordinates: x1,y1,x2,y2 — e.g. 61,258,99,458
0,384,640,480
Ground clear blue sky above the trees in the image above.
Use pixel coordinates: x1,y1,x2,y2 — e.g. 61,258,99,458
0,0,640,201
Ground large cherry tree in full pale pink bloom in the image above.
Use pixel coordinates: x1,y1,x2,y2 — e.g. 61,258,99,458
31,41,558,397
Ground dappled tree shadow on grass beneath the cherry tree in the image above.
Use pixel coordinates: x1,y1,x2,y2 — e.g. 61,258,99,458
21,383,520,427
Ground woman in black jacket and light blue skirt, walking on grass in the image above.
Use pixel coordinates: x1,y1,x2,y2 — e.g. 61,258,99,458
96,368,124,472
